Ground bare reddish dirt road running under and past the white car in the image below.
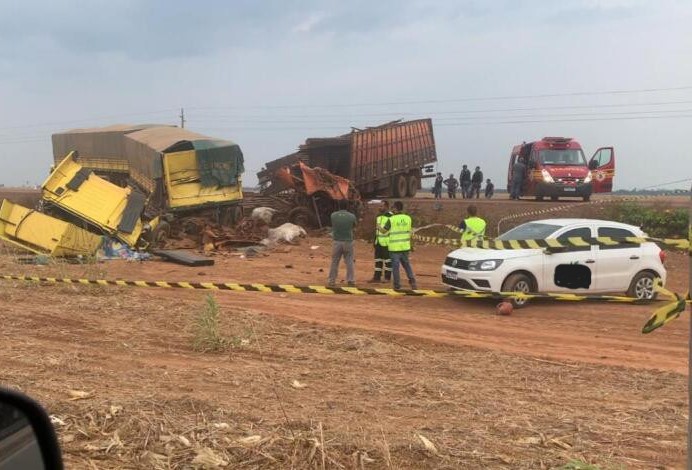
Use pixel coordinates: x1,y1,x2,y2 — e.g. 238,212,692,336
12,239,688,373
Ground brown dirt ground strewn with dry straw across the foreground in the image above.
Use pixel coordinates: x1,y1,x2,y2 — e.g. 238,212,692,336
0,202,688,469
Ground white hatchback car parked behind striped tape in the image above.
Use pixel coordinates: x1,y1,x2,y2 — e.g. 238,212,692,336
442,219,666,307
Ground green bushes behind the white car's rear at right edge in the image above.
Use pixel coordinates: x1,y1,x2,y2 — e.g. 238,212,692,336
611,203,689,238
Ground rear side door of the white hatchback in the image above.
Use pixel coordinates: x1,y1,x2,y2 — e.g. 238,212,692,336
596,226,642,292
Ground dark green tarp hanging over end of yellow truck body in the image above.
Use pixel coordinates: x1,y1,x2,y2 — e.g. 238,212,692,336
192,140,245,187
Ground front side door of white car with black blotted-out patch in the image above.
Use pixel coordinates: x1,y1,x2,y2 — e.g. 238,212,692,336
539,224,598,293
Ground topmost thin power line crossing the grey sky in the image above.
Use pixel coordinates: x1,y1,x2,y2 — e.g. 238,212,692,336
188,86,692,110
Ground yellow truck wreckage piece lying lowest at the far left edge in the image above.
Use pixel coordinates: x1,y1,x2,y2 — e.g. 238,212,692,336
0,200,102,257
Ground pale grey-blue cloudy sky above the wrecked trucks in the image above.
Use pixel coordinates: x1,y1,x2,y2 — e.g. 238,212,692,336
0,0,692,189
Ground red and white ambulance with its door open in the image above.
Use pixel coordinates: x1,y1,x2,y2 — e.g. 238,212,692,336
507,137,615,201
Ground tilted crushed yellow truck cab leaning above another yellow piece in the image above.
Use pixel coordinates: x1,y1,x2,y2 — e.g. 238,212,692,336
42,152,146,247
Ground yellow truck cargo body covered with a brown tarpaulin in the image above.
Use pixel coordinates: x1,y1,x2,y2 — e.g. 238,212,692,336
52,125,244,217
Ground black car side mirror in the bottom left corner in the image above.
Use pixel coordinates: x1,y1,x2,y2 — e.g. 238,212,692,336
0,388,63,470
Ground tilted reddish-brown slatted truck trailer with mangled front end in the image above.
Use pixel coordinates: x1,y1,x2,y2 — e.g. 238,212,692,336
258,119,437,197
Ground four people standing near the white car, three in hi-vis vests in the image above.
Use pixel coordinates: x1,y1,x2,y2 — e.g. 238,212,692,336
327,201,486,290
